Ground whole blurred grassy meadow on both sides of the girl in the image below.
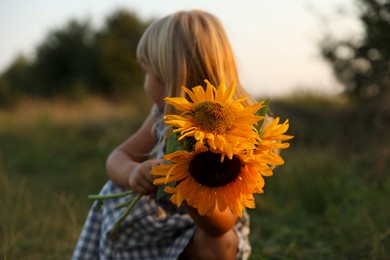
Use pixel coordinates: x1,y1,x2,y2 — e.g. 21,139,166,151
0,95,390,259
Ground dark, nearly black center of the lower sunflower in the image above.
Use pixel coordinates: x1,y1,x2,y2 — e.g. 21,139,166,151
189,152,241,187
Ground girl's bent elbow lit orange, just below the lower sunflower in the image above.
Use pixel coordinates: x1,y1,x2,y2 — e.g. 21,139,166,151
184,203,237,237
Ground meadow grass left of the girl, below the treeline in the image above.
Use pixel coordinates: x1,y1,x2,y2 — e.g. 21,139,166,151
0,98,145,259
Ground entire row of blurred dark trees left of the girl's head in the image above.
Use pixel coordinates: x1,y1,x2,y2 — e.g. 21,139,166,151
0,10,149,106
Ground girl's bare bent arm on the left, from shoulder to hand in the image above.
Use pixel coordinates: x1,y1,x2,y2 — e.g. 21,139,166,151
106,108,161,195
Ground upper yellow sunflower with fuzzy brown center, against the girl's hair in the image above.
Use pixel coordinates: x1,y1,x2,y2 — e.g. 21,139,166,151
161,80,264,159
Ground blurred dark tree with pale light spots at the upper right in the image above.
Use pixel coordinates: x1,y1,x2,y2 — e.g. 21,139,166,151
321,0,390,103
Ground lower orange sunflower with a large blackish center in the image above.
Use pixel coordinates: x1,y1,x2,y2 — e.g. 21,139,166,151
152,146,264,217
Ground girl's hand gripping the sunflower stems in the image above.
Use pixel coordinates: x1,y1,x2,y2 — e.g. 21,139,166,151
129,160,163,195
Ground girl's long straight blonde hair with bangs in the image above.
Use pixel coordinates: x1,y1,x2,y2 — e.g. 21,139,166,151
137,10,254,113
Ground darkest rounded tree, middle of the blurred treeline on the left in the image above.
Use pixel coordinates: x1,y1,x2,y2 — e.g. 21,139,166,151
33,20,97,97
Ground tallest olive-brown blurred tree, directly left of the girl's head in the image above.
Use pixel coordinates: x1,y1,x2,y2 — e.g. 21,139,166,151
96,10,148,98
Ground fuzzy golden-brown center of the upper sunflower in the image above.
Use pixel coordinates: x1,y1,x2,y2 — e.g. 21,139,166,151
191,101,236,133
